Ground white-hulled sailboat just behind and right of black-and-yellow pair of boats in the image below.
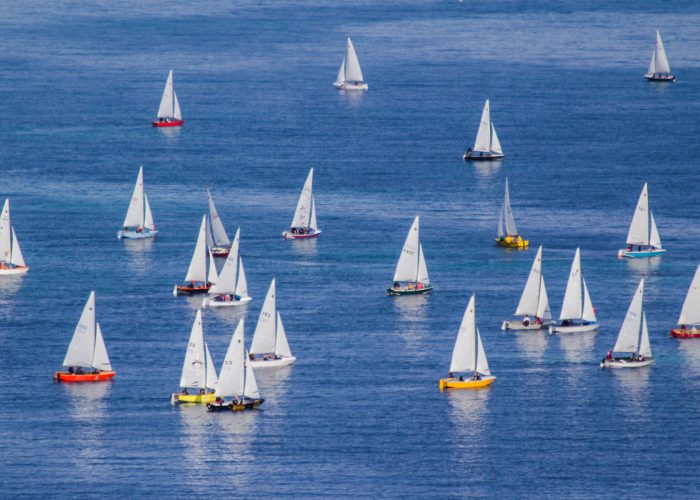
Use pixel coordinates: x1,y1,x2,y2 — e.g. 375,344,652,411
249,278,297,368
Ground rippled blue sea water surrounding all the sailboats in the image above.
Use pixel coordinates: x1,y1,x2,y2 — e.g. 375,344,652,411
0,0,700,497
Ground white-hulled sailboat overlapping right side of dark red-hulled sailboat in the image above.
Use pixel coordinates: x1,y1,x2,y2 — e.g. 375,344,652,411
203,229,251,307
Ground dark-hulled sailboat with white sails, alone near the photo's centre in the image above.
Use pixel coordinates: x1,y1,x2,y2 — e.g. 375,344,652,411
386,215,433,295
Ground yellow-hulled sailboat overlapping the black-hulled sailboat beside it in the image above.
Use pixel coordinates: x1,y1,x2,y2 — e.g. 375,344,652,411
170,309,217,404
